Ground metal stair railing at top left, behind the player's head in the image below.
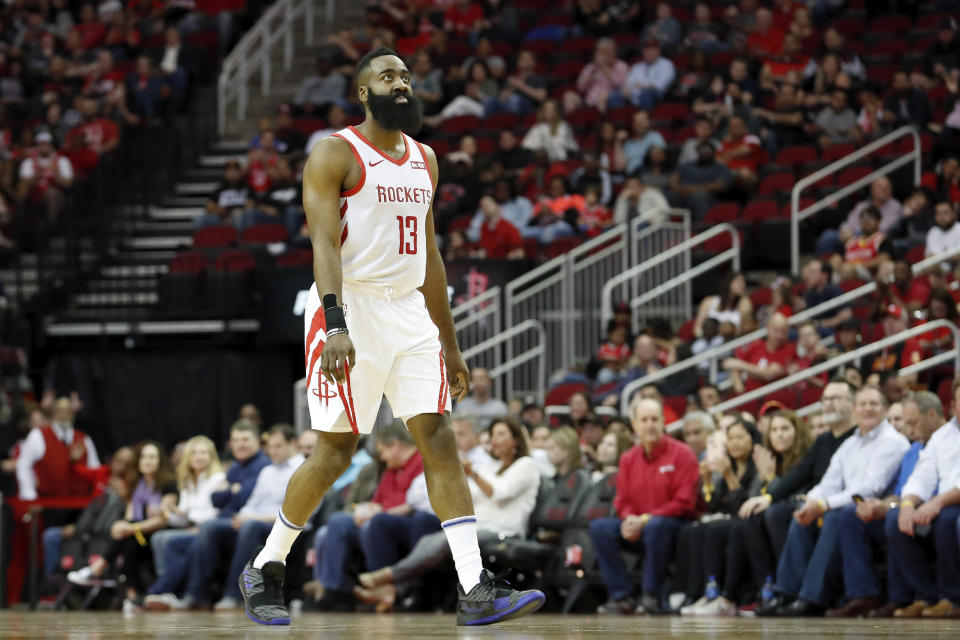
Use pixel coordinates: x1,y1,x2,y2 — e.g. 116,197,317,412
217,0,324,136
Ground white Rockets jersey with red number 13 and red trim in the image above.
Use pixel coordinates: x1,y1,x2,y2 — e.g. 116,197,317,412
333,127,433,290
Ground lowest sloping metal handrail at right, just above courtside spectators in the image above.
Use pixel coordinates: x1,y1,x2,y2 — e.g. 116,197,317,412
664,320,960,430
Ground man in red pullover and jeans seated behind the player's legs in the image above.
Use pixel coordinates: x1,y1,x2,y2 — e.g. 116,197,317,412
317,422,423,611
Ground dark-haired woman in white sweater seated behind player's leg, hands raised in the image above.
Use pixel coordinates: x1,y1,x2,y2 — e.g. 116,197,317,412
355,417,540,611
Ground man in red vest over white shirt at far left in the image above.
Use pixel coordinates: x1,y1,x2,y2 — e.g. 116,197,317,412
17,397,100,500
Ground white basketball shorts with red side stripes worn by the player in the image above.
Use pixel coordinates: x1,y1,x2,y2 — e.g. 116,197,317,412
304,283,450,434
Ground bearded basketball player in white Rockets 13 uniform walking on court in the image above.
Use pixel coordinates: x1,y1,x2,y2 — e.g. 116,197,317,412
240,48,544,625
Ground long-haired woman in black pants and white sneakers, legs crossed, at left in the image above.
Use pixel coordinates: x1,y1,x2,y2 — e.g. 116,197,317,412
67,440,177,611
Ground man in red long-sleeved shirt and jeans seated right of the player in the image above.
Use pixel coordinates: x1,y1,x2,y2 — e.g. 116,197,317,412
590,399,700,614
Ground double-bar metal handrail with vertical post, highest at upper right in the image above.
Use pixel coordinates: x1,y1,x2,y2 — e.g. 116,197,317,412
790,125,922,276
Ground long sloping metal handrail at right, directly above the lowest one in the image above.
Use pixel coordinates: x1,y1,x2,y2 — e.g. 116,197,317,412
622,242,960,406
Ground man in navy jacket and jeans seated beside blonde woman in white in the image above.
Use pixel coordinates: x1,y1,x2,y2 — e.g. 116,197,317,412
144,420,270,611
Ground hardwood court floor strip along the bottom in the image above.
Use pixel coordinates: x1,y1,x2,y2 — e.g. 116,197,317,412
0,610,960,640
